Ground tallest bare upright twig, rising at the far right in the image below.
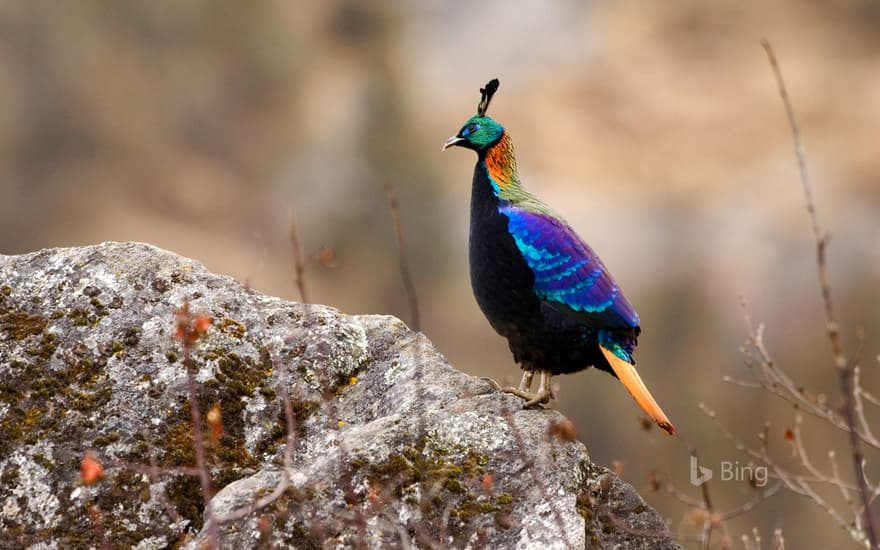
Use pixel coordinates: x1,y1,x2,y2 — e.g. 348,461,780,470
761,39,878,549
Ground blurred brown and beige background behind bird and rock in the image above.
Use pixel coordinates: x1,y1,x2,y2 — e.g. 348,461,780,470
0,0,880,548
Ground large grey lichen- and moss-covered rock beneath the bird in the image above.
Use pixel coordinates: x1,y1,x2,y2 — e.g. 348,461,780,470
0,243,678,549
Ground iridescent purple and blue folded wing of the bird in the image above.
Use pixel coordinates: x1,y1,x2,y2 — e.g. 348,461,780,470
500,205,639,329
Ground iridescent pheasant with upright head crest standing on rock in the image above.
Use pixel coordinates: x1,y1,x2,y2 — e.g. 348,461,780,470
443,79,675,435
